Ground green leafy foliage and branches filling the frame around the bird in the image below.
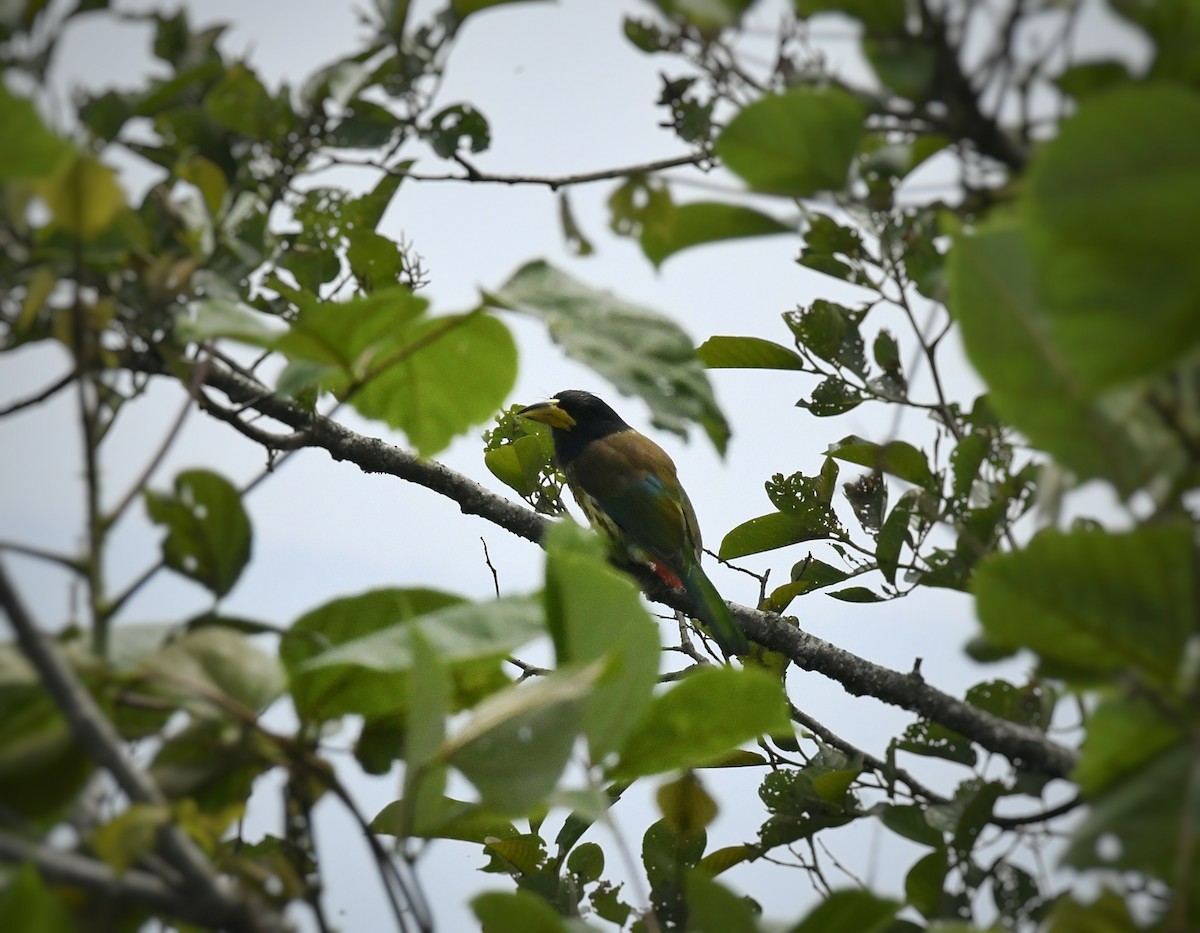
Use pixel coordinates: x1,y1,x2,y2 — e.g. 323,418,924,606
0,0,1200,933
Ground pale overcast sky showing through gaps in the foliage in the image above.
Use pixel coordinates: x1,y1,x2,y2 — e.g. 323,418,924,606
0,0,1135,931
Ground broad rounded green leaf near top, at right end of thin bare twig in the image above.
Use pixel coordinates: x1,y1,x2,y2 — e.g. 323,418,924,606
716,88,866,198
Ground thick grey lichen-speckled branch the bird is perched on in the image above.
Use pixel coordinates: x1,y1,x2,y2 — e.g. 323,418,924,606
136,355,1075,777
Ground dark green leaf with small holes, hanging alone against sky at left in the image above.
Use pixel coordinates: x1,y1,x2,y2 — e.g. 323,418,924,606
145,470,251,596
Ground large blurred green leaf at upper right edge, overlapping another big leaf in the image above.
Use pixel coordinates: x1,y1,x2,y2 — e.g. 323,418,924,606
1022,85,1200,390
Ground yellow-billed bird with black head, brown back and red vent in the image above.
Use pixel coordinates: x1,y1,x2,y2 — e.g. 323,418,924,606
517,389,750,655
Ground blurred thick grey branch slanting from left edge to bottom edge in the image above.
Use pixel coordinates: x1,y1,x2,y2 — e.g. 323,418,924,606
0,564,280,931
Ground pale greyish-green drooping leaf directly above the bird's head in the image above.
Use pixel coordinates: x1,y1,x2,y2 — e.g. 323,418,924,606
487,260,730,452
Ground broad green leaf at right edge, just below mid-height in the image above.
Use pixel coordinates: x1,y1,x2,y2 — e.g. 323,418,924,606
973,522,1198,696
